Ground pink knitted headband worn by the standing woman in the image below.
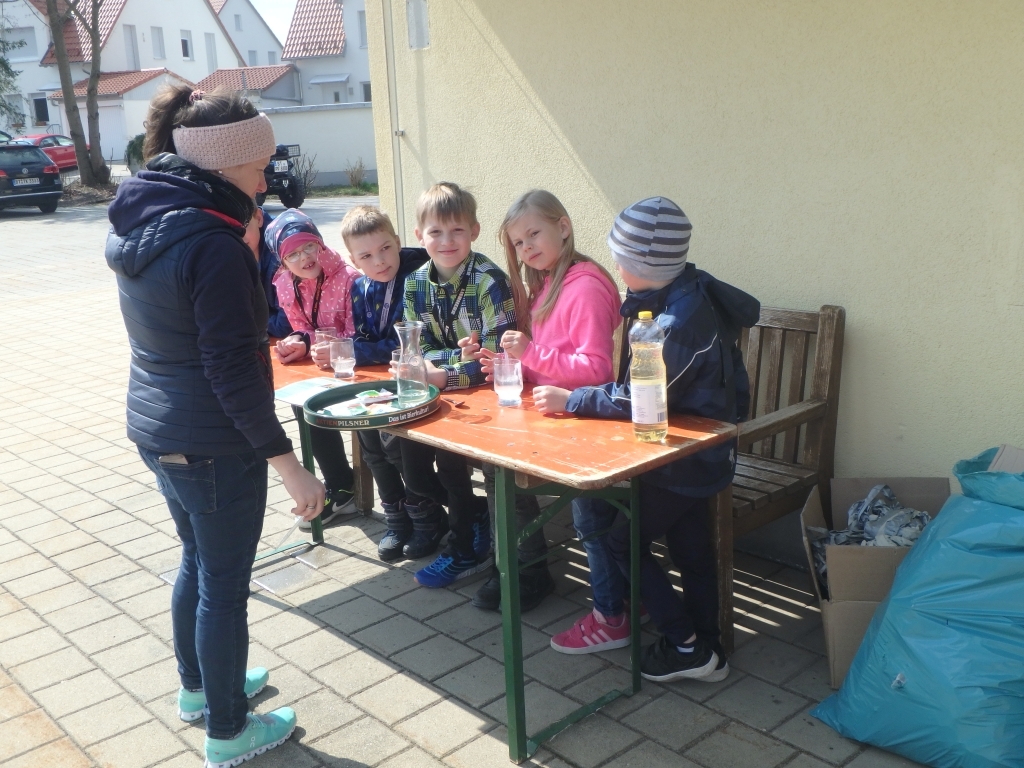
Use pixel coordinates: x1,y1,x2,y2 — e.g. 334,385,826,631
171,113,276,171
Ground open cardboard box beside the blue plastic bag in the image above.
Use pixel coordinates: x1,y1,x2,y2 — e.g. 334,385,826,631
800,477,949,688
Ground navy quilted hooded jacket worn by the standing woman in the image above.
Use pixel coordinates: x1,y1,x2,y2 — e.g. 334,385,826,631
105,165,292,458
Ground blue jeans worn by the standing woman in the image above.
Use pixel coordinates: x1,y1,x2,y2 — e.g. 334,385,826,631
138,447,267,738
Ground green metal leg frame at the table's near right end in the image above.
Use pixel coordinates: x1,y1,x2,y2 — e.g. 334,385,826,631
495,466,640,763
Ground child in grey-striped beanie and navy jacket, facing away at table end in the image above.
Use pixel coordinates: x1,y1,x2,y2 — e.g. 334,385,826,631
534,198,760,682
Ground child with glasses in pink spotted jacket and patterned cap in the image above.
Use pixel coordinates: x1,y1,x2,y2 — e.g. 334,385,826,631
263,209,359,529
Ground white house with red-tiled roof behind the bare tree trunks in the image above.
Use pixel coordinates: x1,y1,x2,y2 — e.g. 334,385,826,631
0,0,244,161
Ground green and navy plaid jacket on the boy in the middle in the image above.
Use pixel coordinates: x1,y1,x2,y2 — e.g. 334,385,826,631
404,252,515,389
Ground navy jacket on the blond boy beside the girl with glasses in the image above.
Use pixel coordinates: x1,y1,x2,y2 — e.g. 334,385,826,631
352,248,429,366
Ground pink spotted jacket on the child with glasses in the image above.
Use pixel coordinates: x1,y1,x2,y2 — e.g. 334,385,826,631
273,247,359,341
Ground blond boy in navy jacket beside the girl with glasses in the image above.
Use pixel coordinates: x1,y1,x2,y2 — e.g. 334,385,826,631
341,206,447,561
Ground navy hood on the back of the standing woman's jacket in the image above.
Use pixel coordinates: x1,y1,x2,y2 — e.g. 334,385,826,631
104,171,241,278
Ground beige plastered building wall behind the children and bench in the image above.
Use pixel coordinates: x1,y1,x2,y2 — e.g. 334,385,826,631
367,0,1024,475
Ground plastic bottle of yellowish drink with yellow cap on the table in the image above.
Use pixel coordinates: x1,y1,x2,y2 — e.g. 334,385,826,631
630,312,669,442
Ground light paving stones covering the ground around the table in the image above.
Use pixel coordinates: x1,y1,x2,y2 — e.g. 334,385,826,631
0,199,929,768
